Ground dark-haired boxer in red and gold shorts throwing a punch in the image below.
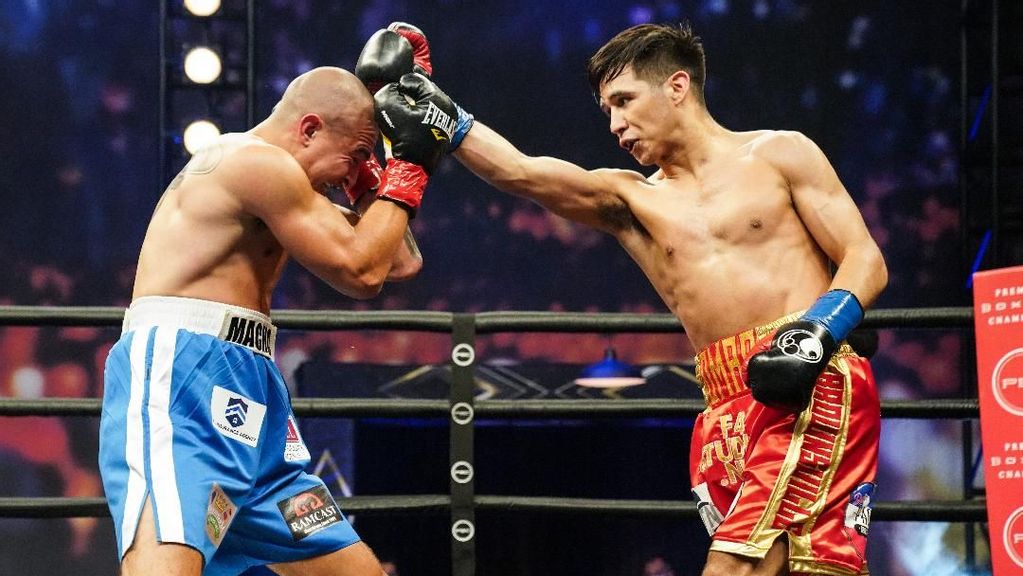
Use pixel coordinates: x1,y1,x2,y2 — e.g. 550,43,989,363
375,19,888,576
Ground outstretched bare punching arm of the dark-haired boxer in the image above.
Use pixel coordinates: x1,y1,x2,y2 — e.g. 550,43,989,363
452,121,646,233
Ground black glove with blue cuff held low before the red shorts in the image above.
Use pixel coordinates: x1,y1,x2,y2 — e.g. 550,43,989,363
747,290,863,412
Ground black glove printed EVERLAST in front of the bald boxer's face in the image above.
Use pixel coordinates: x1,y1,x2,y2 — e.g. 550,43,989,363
373,73,458,174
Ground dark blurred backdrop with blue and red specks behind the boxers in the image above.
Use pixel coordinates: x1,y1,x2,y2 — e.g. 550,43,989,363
0,0,986,576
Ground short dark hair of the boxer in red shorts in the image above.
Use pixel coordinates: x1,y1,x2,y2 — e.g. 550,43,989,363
586,23,707,104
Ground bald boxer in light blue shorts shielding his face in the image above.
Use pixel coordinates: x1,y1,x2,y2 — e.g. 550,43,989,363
99,57,456,576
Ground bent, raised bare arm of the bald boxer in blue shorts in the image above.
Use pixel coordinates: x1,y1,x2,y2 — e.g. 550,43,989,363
232,146,408,299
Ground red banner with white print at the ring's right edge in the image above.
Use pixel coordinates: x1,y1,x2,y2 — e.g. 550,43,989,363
973,266,1023,576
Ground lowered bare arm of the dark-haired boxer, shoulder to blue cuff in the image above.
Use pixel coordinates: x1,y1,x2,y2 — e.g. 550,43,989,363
758,132,888,308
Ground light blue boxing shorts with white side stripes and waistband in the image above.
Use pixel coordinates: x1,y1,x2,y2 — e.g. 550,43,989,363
99,297,359,575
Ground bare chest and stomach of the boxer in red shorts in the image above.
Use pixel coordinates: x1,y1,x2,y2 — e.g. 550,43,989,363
609,132,831,349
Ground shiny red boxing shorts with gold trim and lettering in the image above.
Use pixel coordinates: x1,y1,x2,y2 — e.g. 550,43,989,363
690,315,881,576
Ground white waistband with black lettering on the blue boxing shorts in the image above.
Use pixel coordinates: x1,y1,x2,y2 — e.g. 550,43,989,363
121,296,277,358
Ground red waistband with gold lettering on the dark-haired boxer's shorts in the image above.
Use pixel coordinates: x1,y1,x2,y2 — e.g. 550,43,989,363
697,311,854,407
